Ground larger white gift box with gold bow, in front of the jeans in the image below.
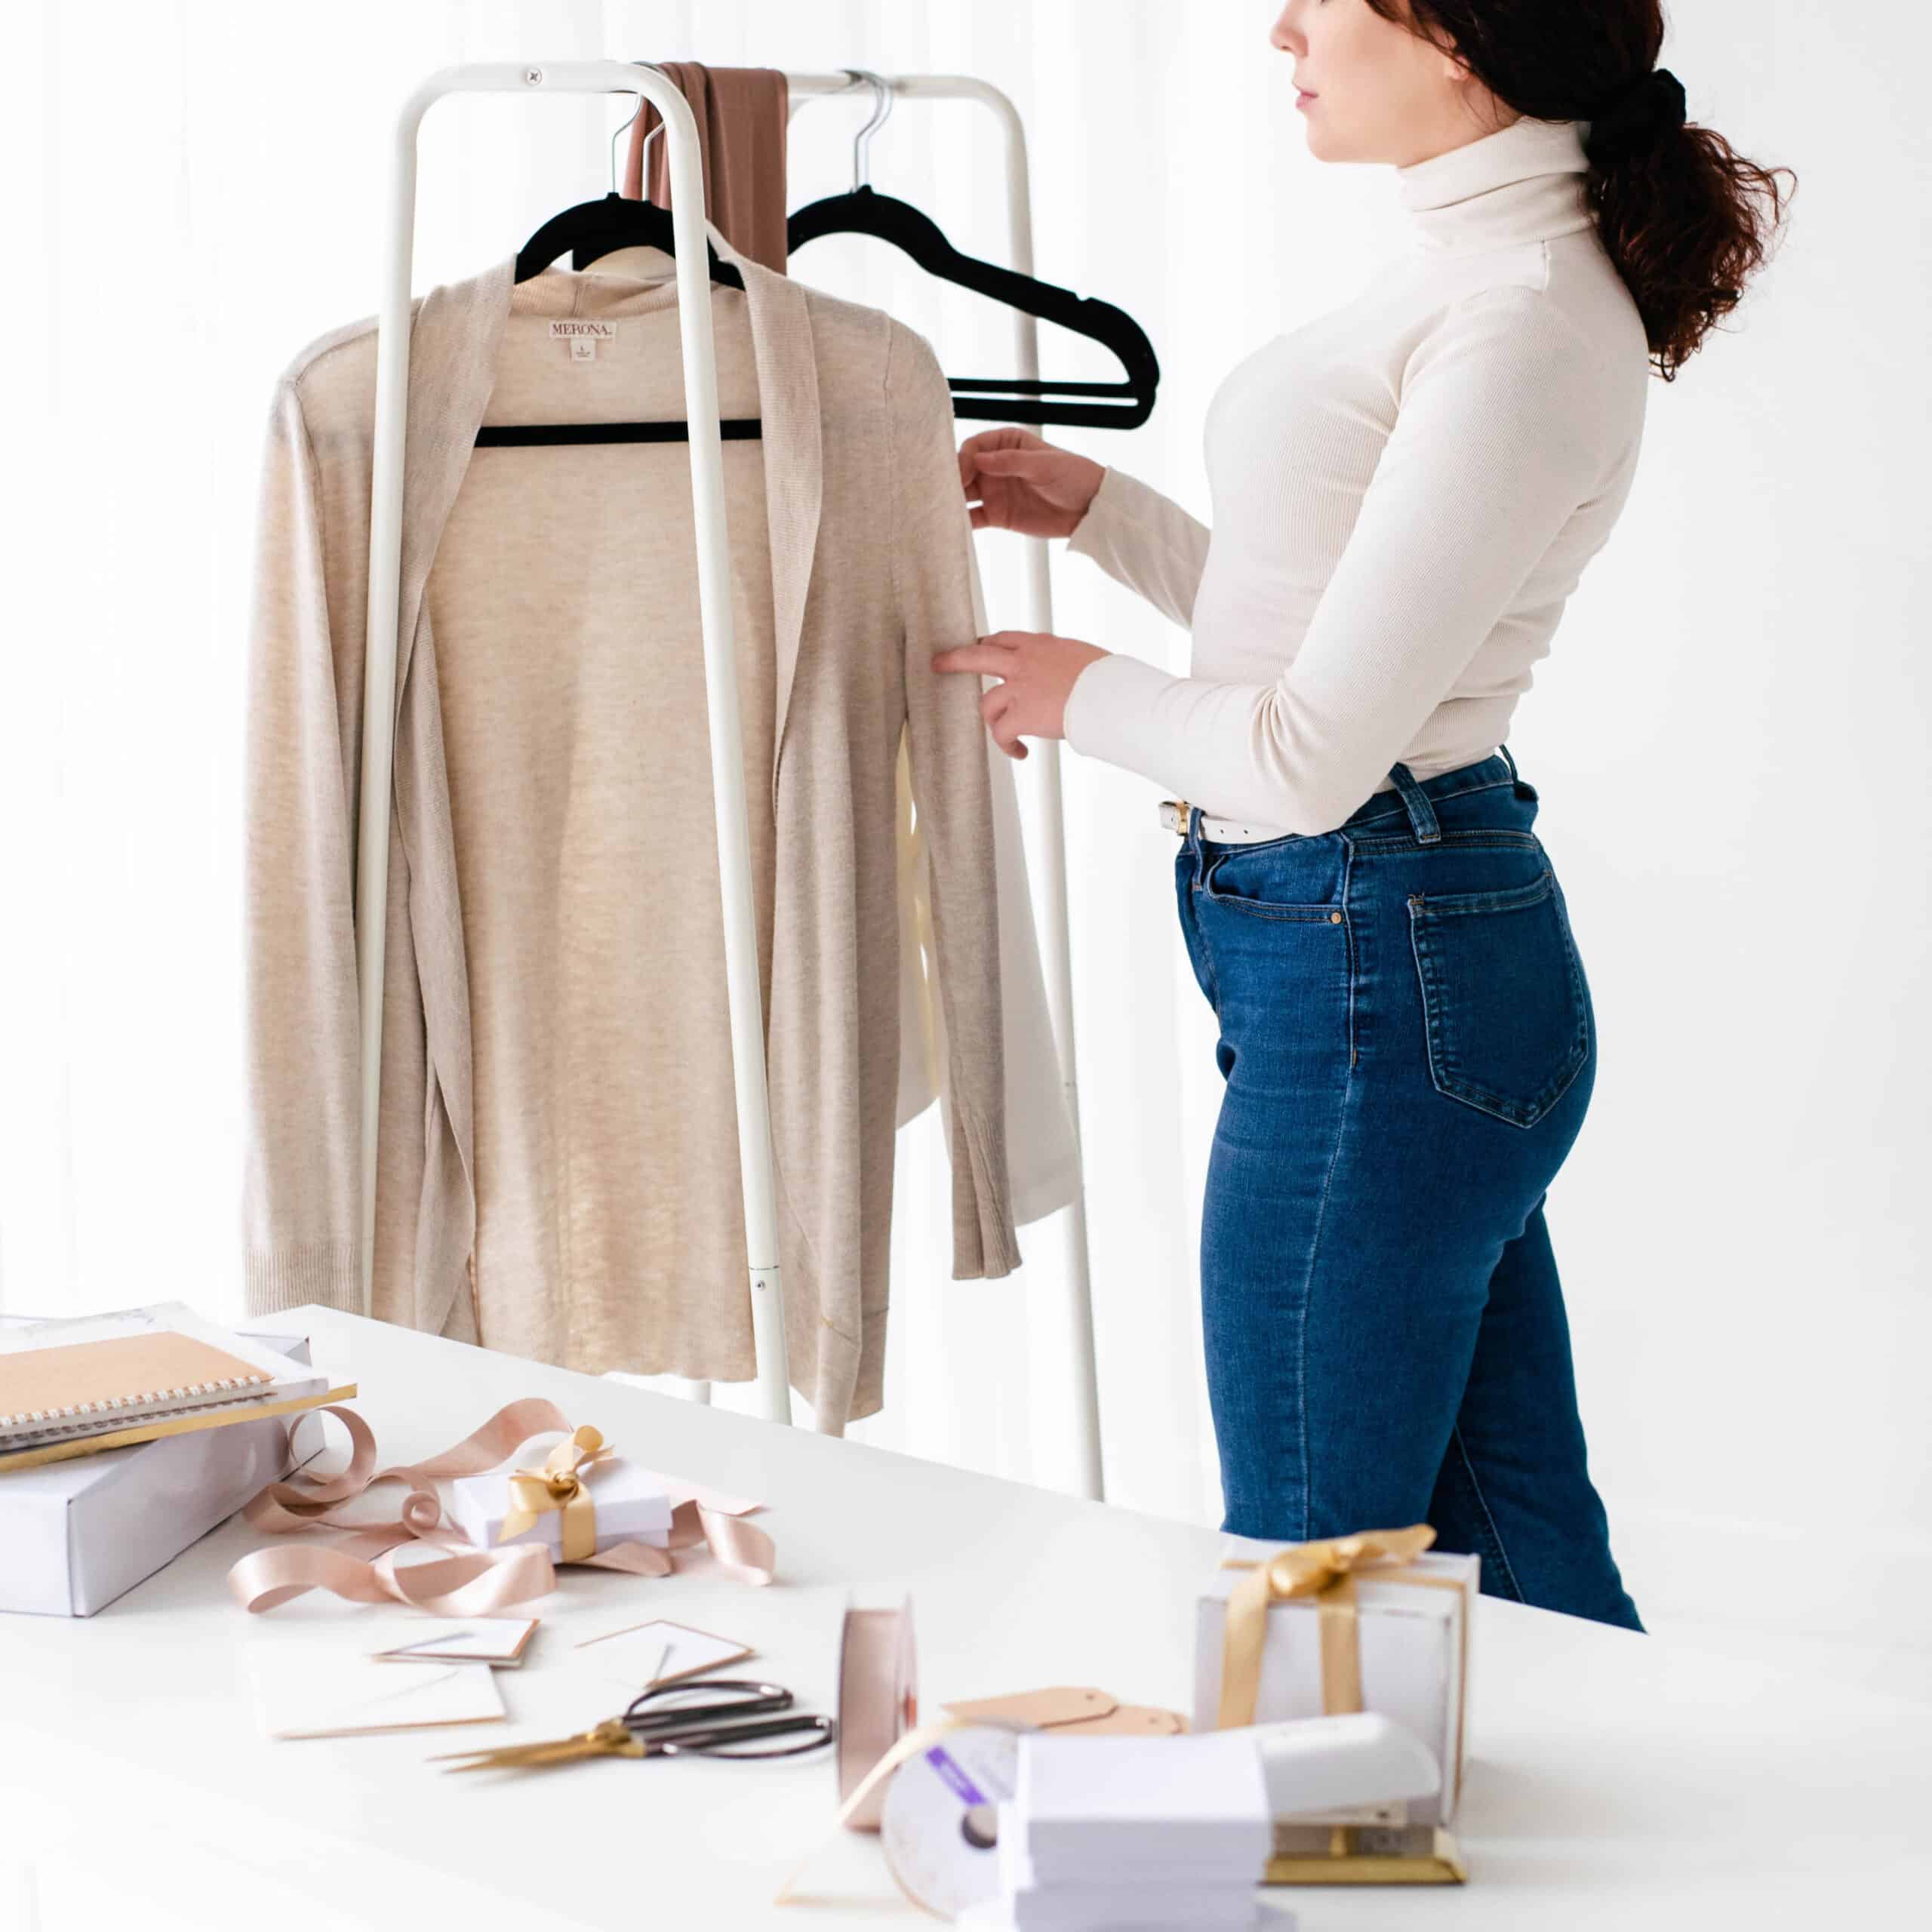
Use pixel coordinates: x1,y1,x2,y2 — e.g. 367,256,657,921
1194,1524,1482,1826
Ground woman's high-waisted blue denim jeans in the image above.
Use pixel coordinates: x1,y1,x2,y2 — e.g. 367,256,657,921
1174,749,1642,1629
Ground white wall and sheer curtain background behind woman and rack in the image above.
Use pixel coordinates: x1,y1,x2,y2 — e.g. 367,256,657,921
0,0,1932,1684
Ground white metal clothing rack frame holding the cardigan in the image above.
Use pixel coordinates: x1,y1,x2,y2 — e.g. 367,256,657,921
355,60,1101,1497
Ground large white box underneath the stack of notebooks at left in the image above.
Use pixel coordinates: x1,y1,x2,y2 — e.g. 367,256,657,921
0,1329,309,1617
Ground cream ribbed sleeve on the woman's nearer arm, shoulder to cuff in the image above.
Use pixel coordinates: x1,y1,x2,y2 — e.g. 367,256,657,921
1066,284,1627,832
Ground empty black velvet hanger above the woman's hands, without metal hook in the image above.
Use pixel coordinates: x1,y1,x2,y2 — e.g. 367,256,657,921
784,187,1161,429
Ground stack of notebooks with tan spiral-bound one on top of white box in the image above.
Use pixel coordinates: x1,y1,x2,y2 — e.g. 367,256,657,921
0,1302,331,1469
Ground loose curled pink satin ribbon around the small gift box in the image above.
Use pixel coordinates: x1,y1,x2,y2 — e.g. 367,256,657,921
228,1395,777,1617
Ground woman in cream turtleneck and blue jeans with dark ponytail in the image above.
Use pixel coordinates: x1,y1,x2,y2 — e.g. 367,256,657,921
937,0,1781,1629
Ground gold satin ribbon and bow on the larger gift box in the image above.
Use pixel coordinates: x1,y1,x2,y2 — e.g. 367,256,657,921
1215,1522,1457,1731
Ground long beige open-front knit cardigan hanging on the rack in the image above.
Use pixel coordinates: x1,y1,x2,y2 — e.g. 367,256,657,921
245,230,1018,1429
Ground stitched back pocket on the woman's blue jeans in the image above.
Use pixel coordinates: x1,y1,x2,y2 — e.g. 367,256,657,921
1408,867,1590,1126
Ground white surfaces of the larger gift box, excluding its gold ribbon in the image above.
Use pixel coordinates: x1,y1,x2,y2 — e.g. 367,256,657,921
1194,1536,1482,1826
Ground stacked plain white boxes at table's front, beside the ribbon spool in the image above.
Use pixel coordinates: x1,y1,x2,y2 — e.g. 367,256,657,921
991,1731,1279,1932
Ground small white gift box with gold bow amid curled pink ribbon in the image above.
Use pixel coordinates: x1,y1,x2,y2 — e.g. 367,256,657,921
450,1426,670,1563
